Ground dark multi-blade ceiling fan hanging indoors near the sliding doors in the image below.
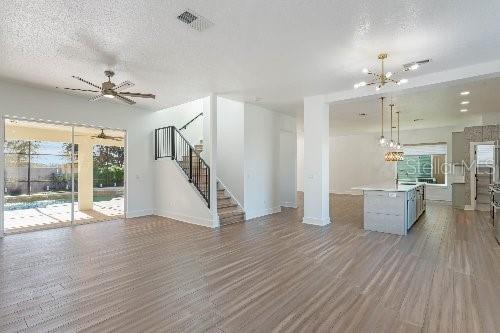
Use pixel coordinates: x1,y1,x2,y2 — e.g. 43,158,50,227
57,70,155,105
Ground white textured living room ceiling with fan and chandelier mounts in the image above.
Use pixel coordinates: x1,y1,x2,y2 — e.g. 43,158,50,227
0,0,500,113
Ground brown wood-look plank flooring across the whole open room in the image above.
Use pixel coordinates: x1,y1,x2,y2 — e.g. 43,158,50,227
0,195,500,332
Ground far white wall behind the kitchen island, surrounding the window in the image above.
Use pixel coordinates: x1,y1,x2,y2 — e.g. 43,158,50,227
297,127,463,201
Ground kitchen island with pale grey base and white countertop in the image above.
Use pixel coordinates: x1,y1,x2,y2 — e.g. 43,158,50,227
355,183,426,235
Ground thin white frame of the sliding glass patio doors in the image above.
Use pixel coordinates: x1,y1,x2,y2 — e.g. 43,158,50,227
0,115,128,238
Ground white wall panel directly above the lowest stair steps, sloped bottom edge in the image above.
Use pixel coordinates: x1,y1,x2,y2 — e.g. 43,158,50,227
217,97,245,206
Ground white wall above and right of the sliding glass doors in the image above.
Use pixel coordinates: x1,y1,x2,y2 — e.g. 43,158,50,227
0,78,154,217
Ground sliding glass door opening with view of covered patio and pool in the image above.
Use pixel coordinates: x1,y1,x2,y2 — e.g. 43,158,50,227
3,119,126,233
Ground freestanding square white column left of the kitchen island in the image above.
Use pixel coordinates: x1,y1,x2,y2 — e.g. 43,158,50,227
302,96,330,226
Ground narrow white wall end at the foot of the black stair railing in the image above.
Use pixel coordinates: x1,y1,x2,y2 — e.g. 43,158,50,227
203,94,219,228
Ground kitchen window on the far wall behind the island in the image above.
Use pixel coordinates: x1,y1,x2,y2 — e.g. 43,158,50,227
397,143,447,184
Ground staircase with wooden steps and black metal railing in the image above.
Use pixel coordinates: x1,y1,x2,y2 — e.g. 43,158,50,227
155,126,245,227
